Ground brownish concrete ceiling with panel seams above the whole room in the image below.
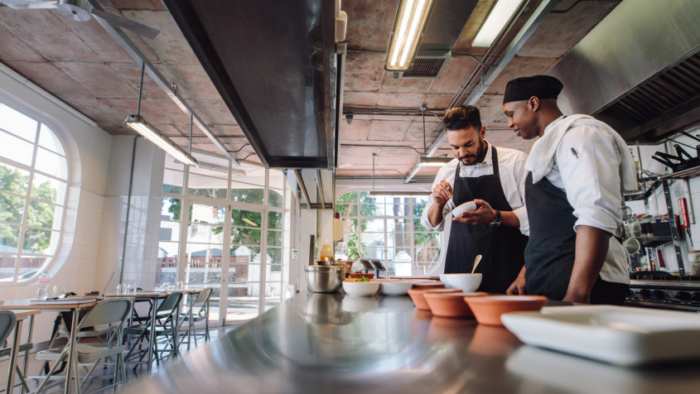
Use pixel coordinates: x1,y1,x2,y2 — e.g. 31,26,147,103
0,0,617,177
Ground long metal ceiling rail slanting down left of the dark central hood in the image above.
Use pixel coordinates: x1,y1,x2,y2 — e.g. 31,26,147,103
89,0,238,165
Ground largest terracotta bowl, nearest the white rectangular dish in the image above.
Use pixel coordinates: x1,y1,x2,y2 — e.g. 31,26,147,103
464,295,547,326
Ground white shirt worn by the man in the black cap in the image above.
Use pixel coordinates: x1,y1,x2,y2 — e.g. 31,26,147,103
544,117,630,283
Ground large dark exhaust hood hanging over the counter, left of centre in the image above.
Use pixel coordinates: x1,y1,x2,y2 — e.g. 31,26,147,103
163,0,340,169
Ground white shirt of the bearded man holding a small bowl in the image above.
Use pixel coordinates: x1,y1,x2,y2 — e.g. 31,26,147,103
421,144,530,235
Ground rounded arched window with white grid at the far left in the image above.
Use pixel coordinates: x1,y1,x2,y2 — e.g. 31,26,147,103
0,103,69,283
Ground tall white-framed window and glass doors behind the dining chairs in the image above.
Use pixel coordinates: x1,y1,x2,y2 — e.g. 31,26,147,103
156,153,291,323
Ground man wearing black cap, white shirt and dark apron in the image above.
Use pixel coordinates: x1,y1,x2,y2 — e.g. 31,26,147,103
503,75,637,304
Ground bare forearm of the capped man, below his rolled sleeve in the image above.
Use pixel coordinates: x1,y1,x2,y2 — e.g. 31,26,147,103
564,226,610,303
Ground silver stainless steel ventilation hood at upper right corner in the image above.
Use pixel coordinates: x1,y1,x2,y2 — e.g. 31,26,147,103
549,0,700,142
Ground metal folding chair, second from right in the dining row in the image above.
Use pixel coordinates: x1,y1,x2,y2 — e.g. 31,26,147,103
124,292,182,365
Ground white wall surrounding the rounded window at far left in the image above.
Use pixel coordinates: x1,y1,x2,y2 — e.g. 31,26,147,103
0,64,112,342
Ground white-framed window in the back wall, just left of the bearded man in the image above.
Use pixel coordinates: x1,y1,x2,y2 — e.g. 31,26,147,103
335,191,442,276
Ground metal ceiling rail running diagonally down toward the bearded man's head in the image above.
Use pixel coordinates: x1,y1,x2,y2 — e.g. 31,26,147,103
404,0,559,183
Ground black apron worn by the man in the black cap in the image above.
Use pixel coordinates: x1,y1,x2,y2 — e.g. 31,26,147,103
525,173,628,305
